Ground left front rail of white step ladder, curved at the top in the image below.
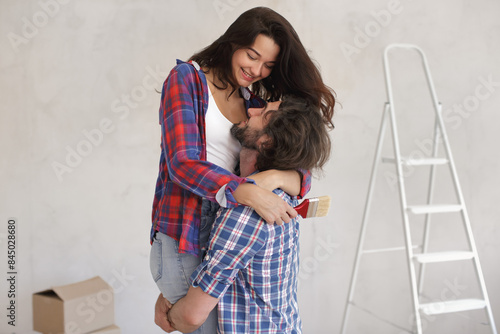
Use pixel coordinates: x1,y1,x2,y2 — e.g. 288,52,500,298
383,44,422,334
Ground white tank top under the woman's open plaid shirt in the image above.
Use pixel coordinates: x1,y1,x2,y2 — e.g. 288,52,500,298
205,89,241,173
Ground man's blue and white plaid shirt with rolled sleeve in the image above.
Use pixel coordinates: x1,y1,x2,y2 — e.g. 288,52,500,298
191,189,302,334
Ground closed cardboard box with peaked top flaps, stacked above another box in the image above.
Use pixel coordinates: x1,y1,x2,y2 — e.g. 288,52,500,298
33,276,114,334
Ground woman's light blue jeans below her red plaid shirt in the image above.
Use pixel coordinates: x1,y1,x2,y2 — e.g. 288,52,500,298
149,199,219,334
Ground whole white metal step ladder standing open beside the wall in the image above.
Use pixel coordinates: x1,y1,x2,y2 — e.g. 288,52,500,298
341,44,497,334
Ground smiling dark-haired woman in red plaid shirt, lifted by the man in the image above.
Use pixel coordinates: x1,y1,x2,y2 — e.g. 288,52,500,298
151,7,335,333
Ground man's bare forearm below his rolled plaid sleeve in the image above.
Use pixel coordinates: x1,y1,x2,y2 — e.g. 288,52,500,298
167,286,219,333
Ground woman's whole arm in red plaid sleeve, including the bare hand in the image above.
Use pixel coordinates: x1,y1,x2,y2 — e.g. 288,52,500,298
160,64,297,224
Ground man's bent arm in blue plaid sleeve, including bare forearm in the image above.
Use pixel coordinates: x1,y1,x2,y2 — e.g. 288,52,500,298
167,206,267,333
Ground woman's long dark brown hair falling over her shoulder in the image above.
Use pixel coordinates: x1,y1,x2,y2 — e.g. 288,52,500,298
190,7,335,129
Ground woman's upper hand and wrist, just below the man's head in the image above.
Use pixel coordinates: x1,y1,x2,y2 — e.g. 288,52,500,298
248,169,302,196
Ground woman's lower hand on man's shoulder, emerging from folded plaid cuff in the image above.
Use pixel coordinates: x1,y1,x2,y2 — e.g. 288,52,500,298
233,183,297,225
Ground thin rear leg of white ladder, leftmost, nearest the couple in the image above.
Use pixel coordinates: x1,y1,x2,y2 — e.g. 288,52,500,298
340,103,389,334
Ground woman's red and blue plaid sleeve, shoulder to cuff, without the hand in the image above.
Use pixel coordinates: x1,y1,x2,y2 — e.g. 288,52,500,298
160,63,248,207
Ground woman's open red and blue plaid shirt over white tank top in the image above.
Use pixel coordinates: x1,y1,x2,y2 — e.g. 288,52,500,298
151,60,311,255
